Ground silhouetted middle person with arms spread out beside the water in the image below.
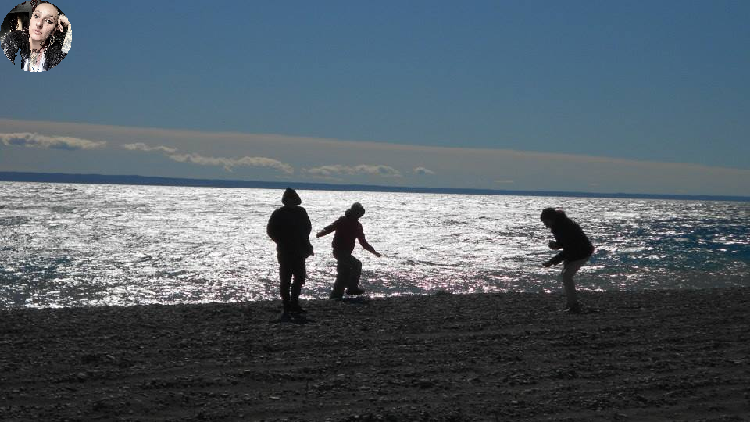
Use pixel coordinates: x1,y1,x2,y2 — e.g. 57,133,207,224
316,202,380,299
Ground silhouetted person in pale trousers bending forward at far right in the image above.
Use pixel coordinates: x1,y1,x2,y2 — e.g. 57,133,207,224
541,208,594,313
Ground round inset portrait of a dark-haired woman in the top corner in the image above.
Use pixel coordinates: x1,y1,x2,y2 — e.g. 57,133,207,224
0,0,73,72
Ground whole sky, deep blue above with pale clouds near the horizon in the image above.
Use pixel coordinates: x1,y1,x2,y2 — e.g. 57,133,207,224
0,0,750,195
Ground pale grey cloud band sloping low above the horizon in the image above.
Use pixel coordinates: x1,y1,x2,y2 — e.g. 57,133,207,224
0,119,750,196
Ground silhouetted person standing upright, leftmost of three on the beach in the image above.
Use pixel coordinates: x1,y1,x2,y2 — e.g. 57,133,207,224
266,188,313,316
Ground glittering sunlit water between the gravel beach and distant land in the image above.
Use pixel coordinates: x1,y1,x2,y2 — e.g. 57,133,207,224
0,182,750,308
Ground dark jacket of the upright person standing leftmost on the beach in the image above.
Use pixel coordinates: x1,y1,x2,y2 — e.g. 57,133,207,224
266,205,312,258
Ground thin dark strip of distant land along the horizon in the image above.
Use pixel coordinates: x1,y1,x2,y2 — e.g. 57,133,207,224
0,172,750,202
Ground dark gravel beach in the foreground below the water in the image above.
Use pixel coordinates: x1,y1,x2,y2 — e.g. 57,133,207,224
0,289,750,421
